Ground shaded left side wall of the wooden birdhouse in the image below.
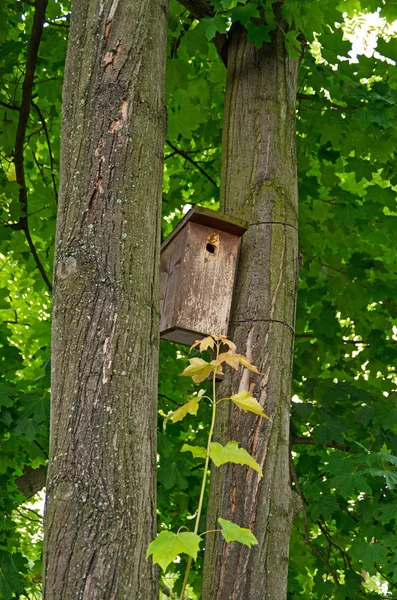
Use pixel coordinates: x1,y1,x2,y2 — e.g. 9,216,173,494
160,227,187,332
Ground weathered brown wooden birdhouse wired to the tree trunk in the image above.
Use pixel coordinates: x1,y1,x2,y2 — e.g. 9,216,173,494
160,207,247,345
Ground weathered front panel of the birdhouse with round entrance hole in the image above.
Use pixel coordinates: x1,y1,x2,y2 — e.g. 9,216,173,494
176,223,240,335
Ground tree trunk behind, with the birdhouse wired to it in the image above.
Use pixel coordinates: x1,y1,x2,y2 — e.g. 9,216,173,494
203,25,298,600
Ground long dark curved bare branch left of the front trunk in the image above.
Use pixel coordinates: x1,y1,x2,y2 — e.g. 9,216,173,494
13,0,52,291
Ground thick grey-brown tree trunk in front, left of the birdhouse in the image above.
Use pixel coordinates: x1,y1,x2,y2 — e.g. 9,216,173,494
44,0,168,600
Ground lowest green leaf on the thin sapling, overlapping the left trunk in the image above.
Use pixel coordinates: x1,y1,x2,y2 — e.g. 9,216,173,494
146,531,202,572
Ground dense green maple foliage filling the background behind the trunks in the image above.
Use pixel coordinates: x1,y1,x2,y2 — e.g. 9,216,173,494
0,0,397,600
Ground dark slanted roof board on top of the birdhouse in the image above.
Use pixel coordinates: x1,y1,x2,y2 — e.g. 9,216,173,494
161,206,248,250
